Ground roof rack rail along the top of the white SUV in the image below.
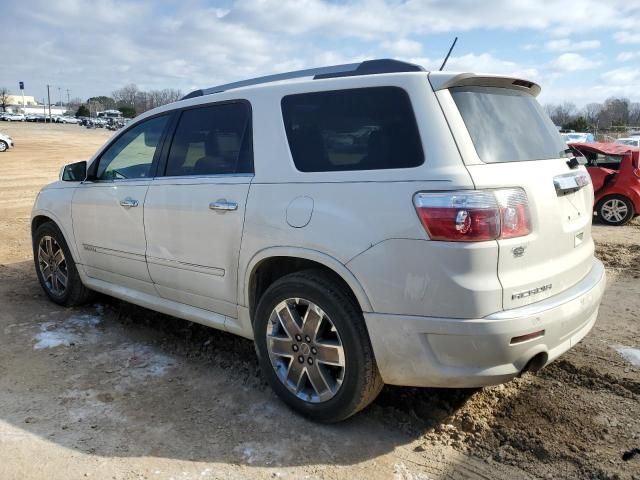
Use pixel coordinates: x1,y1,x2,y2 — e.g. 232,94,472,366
180,58,425,100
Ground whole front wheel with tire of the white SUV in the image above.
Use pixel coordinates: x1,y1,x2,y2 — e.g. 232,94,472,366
33,222,93,307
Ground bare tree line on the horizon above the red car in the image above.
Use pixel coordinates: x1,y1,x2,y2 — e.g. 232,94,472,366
544,97,640,133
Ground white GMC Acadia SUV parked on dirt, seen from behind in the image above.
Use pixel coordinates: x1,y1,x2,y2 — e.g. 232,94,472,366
32,60,605,421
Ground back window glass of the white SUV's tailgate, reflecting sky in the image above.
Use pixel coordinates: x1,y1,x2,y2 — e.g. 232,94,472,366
450,87,567,163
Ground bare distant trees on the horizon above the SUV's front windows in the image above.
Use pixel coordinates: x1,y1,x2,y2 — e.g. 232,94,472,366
68,83,183,118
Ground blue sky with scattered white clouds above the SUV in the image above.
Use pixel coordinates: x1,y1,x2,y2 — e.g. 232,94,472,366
0,0,640,105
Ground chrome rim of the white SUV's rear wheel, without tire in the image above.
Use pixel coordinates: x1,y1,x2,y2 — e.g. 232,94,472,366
266,298,345,403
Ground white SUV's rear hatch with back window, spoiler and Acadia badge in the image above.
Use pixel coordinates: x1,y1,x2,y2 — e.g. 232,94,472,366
430,74,593,309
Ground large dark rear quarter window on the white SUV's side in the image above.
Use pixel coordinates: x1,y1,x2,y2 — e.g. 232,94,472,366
282,87,424,172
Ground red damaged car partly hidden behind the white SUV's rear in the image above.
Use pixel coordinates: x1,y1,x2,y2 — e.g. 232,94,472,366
569,143,640,225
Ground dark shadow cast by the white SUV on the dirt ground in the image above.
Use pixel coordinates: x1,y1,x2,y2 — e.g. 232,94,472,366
0,262,484,465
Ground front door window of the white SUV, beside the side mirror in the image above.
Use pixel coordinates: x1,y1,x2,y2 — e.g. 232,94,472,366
96,115,168,180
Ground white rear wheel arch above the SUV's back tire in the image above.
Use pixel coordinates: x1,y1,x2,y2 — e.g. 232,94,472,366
241,247,372,318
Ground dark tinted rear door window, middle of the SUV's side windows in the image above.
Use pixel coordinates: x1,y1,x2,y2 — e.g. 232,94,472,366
166,103,253,176
